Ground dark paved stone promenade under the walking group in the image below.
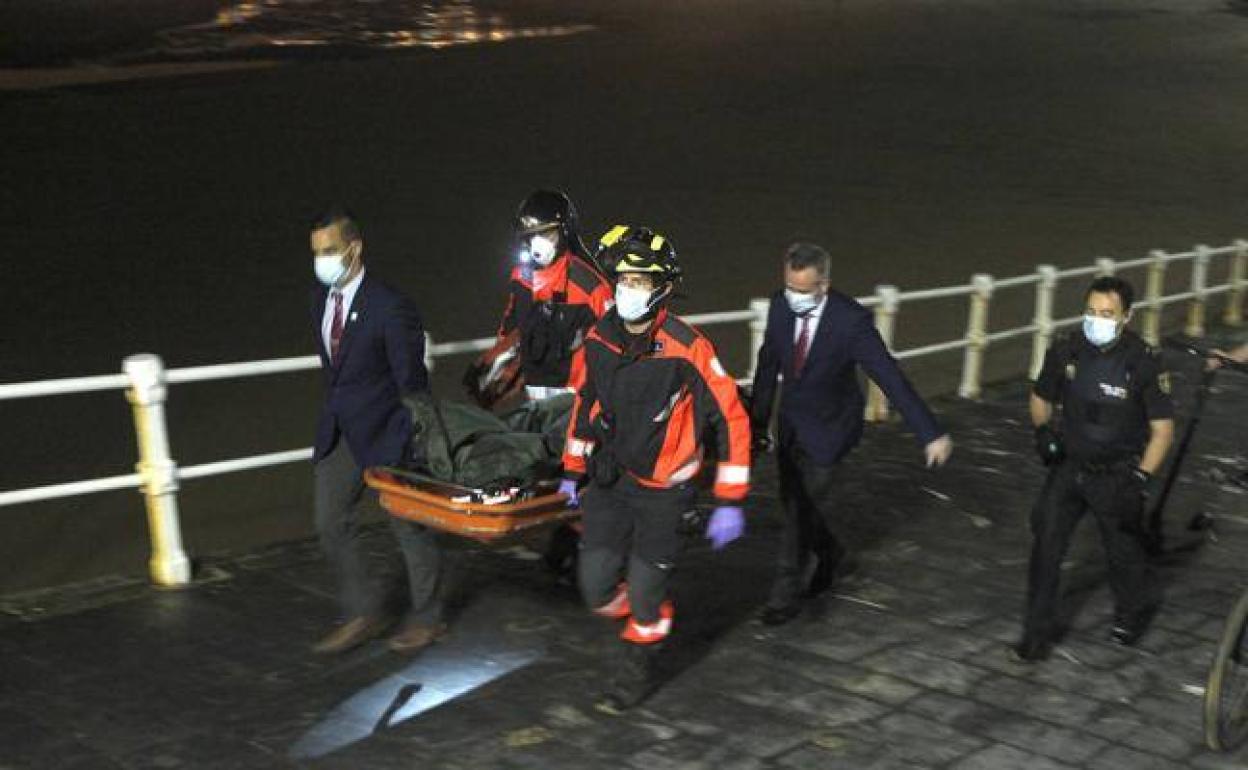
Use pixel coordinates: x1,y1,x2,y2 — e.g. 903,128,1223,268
0,331,1248,770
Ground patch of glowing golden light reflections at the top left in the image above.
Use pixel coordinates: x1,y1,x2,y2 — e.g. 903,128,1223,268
152,0,593,57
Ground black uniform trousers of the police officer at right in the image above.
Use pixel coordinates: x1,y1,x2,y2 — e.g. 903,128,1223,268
1022,459,1161,646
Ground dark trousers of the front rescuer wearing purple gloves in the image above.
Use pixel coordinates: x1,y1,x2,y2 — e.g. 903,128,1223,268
579,473,695,624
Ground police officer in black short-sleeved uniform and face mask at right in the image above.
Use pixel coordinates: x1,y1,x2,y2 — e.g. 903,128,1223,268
1011,277,1174,661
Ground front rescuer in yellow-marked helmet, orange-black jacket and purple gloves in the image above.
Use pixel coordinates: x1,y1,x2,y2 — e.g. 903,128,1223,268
560,226,750,710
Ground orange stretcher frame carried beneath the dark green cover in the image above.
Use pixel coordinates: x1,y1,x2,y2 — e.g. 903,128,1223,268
364,468,580,543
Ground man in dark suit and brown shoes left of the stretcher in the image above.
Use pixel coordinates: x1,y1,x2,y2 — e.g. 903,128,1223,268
311,210,446,653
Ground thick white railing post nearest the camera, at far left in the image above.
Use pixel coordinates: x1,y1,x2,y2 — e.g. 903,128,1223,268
121,353,191,588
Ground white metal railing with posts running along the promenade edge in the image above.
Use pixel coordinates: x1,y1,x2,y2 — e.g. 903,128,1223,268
0,241,1248,587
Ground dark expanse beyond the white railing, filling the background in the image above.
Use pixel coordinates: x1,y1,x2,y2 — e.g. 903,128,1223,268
0,0,1248,589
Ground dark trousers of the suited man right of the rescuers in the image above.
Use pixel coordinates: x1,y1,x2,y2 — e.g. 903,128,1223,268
768,447,850,607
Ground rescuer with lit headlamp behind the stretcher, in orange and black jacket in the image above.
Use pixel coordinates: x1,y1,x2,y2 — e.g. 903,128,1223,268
464,190,612,408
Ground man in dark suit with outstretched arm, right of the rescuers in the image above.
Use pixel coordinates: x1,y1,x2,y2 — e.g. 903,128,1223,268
750,243,953,625
